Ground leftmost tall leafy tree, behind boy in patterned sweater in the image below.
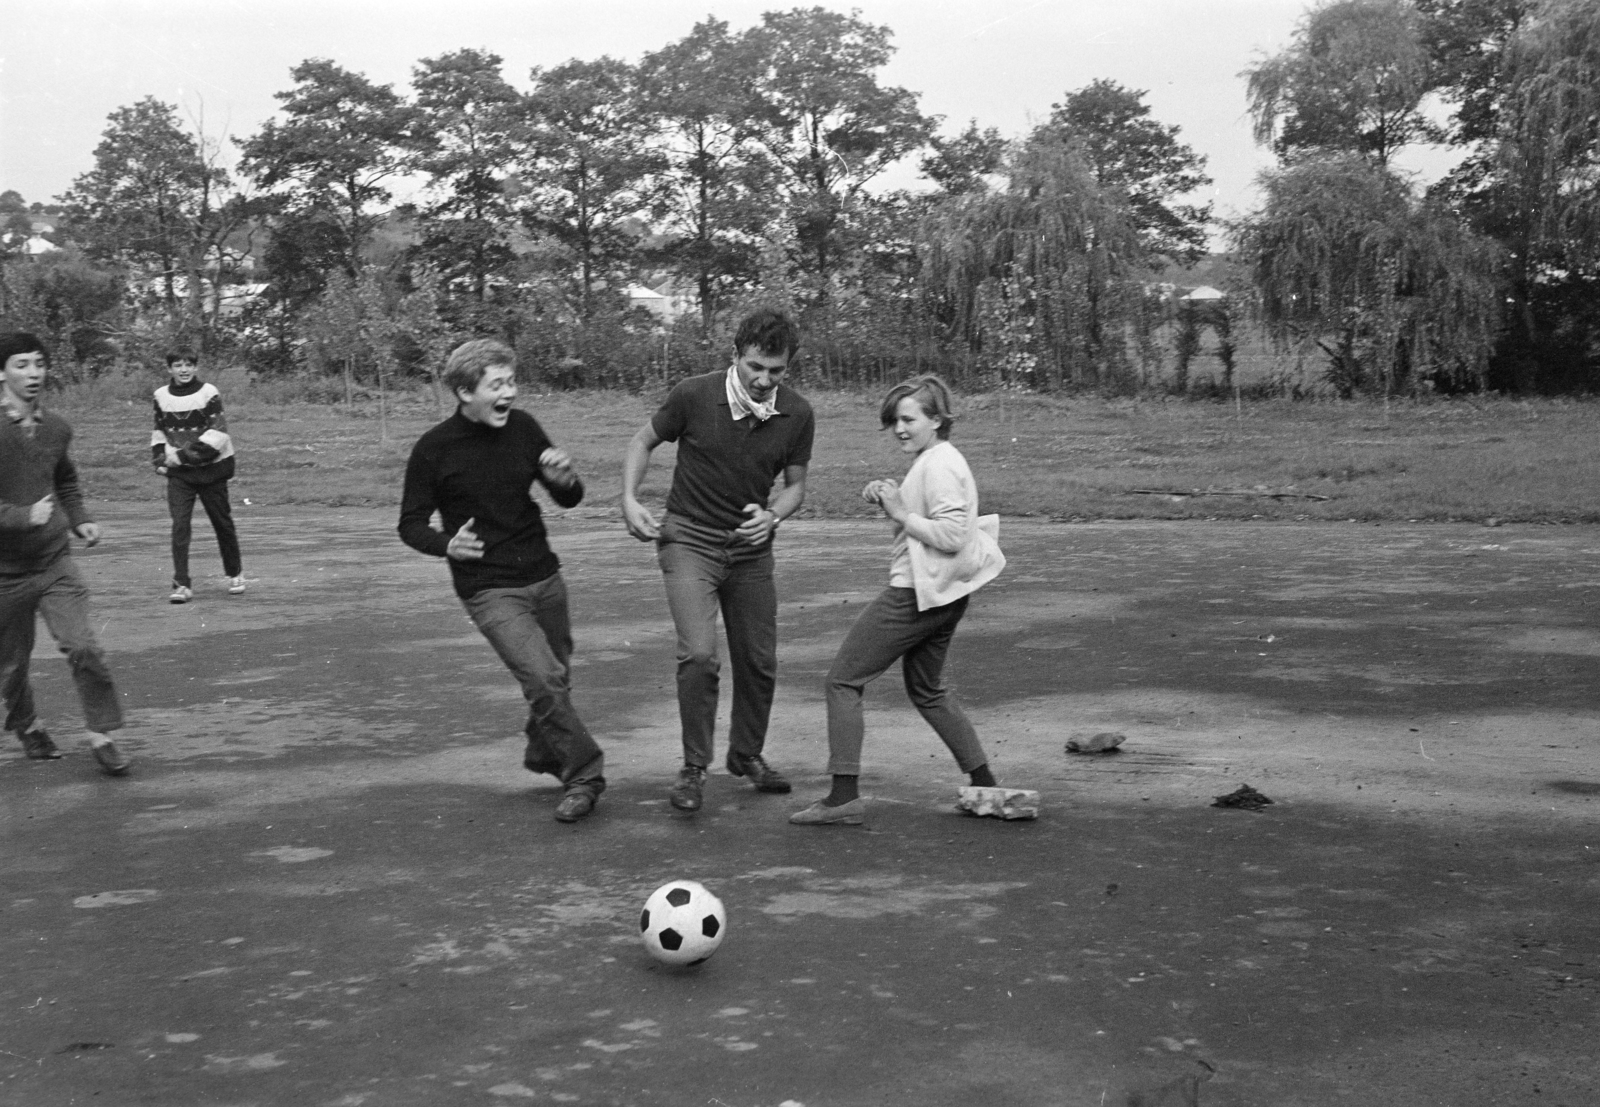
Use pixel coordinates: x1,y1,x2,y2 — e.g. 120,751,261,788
62,96,250,332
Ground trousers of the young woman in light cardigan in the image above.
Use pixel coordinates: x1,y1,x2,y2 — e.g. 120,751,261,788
826,589,989,776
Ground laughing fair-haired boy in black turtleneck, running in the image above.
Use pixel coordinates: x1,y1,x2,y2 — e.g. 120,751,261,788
400,339,605,822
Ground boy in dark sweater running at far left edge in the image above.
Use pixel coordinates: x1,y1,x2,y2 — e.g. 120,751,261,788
0,331,128,776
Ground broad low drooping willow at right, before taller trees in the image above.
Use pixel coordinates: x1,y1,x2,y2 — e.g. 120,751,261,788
1234,155,1502,397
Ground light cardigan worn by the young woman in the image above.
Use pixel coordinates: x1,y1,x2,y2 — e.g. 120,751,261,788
890,442,1005,611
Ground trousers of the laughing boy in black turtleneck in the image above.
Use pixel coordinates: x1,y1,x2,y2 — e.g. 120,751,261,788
462,573,605,795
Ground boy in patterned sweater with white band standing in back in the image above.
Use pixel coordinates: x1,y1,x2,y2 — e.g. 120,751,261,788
150,350,245,603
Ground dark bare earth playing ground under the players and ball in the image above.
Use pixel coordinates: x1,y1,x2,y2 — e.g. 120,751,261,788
0,504,1600,1107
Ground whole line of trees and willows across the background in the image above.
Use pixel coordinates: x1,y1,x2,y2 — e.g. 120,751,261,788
0,0,1600,395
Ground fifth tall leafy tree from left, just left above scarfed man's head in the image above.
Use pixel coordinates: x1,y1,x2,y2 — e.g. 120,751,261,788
640,19,774,326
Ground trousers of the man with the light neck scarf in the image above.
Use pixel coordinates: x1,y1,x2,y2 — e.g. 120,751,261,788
656,515,778,768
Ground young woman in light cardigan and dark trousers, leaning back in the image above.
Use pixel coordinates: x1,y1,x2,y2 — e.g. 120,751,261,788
789,374,1005,825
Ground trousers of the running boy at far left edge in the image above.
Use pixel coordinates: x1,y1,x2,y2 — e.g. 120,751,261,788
0,555,122,734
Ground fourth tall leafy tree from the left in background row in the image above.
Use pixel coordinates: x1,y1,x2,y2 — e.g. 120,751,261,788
522,58,664,320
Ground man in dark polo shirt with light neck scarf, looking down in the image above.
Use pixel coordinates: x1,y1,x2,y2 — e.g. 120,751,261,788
622,309,814,811
